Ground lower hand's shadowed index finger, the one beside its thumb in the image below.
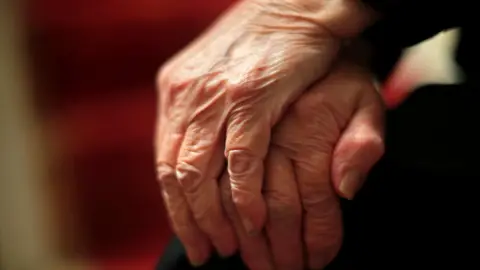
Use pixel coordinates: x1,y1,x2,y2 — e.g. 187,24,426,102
272,81,343,269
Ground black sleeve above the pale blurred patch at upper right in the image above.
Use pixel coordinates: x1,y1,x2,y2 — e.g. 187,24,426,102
363,0,470,79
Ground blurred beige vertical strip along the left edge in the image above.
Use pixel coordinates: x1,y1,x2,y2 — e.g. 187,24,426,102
0,0,61,270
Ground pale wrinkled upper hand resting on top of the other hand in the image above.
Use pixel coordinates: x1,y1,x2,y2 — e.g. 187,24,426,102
155,0,374,264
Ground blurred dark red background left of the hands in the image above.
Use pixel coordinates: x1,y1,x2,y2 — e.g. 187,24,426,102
27,0,233,269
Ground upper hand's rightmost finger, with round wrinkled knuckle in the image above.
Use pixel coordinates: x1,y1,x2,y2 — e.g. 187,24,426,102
225,109,271,234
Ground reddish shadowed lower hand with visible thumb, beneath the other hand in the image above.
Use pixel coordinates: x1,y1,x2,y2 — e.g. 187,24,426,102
222,59,384,270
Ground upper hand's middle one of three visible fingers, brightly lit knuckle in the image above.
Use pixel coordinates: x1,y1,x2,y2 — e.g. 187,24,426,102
176,117,237,256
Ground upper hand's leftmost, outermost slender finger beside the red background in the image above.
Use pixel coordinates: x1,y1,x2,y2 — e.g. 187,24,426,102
155,121,210,265
